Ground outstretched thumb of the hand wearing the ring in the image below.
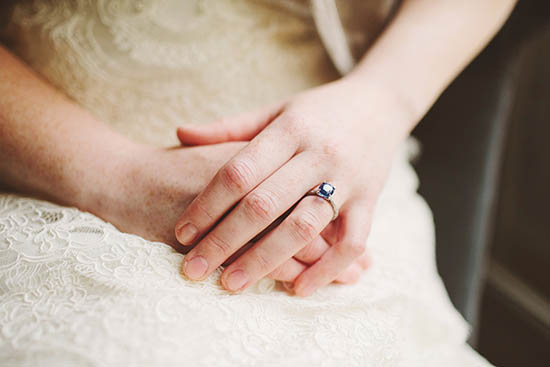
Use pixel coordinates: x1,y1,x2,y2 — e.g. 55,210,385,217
177,102,284,146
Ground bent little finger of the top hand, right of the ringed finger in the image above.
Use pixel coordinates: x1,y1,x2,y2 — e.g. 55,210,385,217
295,202,370,296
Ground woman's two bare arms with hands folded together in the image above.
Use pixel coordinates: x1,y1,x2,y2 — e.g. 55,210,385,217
0,0,515,296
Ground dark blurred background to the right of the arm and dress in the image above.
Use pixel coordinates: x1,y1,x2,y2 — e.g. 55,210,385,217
413,0,550,367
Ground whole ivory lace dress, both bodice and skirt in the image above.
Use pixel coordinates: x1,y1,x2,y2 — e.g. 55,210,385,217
0,0,496,367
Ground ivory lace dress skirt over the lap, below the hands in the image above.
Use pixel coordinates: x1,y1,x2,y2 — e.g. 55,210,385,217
0,151,472,366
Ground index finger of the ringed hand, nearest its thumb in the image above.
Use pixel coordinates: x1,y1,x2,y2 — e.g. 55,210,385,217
175,121,297,245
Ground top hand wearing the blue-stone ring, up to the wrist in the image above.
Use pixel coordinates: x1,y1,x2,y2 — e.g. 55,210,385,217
176,79,408,296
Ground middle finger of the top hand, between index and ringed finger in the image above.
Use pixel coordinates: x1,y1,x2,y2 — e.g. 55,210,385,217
183,153,330,280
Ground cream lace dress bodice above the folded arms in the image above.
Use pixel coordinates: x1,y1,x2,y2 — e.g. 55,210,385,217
1,0,396,145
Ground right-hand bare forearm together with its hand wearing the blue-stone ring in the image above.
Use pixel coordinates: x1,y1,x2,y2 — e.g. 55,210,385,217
176,0,514,296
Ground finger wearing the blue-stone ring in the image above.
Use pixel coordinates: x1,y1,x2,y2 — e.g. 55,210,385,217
221,196,332,292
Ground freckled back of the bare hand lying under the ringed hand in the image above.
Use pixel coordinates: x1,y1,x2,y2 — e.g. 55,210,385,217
91,143,246,252
